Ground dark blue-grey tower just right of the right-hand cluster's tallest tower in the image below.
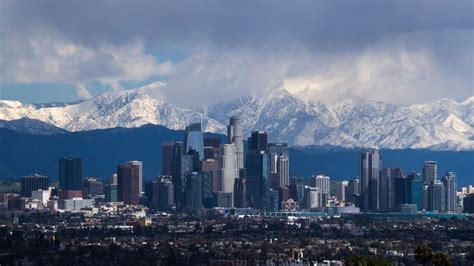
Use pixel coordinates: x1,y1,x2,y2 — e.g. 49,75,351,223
379,168,404,210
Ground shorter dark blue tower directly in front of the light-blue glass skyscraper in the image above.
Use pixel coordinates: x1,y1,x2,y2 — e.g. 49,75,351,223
185,172,203,210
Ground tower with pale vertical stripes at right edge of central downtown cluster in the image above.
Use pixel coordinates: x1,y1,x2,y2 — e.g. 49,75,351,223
268,143,290,187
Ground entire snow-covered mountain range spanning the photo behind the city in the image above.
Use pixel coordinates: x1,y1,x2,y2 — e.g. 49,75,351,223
0,83,474,150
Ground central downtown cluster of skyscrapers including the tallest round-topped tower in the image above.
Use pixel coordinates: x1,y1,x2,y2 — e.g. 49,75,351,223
158,117,289,210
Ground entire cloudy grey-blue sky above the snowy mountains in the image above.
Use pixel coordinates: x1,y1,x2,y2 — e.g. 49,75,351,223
0,0,474,106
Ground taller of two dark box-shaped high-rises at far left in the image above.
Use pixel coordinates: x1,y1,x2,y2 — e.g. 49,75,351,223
59,158,82,191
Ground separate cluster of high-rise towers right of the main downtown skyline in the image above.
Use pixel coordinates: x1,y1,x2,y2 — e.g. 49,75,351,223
350,150,458,212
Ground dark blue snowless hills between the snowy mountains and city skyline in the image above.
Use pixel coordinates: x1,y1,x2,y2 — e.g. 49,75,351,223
0,125,474,185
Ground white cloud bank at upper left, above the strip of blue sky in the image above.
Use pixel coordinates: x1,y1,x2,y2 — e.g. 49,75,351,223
0,30,173,91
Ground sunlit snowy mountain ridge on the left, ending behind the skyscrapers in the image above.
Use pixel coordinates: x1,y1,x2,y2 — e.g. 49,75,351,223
0,84,225,132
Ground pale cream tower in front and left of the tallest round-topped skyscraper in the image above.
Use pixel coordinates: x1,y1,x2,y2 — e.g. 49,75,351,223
217,144,239,195
